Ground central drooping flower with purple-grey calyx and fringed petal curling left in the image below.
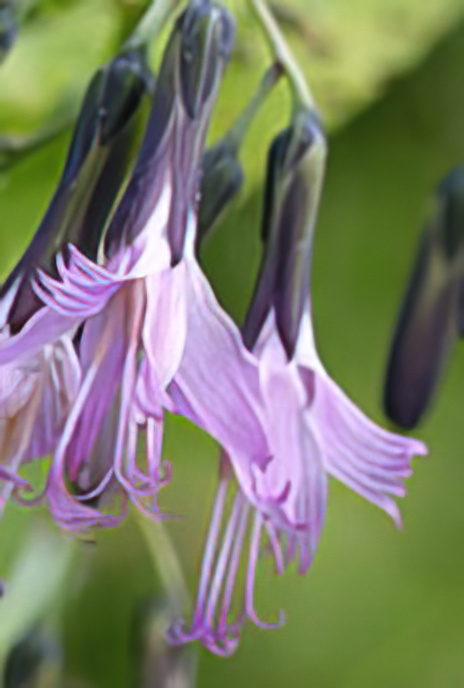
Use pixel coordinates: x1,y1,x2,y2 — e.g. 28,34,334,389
0,0,239,530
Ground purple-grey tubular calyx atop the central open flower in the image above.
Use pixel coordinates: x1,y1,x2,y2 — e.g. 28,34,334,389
105,0,234,265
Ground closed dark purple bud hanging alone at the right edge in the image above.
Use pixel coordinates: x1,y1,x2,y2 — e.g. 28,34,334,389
384,167,464,428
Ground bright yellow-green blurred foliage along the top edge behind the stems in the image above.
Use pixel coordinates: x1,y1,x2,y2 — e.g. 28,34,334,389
0,0,464,175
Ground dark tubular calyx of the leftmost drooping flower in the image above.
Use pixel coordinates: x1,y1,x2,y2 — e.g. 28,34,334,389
0,52,149,331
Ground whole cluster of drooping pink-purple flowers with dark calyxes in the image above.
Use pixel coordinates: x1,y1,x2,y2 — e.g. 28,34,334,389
0,0,426,655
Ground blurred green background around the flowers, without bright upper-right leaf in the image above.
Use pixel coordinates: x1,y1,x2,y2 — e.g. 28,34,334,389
0,0,464,688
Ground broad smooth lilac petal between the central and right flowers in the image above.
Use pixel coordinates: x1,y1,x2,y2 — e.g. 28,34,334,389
168,260,269,476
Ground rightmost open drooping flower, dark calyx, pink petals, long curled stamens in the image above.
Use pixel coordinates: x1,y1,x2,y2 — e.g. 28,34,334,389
169,112,426,656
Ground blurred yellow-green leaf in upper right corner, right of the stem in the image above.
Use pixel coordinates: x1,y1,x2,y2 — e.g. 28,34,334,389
262,0,464,124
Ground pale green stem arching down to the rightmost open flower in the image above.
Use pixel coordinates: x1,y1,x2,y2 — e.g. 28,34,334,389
248,0,316,110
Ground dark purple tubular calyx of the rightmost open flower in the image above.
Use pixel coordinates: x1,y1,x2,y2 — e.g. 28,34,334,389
243,111,326,359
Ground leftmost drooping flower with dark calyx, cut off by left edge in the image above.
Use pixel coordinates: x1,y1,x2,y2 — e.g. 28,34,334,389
0,47,150,520
